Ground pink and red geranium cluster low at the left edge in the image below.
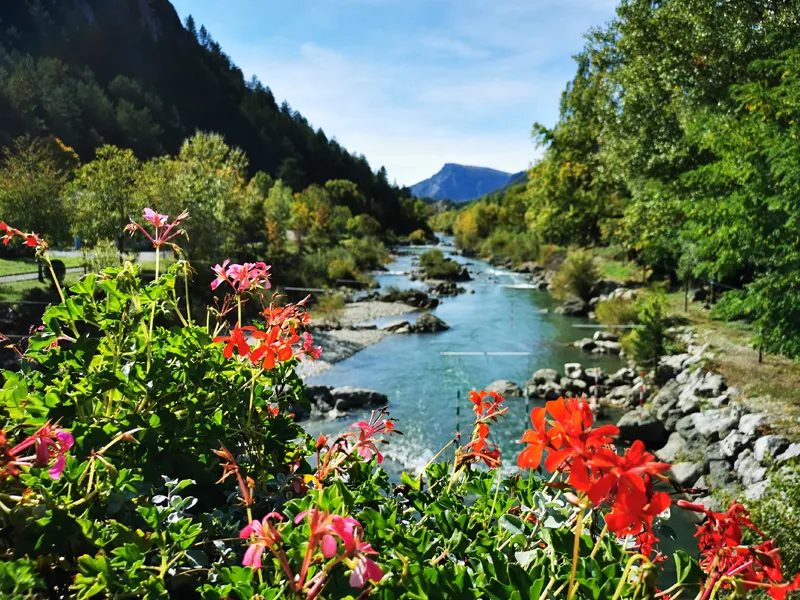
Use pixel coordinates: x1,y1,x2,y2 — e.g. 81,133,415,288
0,422,75,479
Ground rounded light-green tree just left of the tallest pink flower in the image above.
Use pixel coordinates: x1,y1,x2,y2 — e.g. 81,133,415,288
68,146,144,252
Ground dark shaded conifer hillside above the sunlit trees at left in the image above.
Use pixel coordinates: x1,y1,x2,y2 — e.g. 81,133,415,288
0,0,408,227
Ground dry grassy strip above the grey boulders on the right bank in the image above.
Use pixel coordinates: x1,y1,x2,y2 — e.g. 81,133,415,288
667,292,800,441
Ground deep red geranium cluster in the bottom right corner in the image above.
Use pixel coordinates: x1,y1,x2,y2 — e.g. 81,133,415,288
677,500,800,600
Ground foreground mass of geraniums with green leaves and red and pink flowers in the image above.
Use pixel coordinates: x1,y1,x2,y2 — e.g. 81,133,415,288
0,209,800,600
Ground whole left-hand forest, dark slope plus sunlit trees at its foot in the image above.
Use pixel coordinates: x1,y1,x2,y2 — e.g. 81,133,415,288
0,0,426,270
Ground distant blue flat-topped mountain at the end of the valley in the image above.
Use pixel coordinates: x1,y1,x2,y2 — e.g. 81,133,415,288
409,163,526,202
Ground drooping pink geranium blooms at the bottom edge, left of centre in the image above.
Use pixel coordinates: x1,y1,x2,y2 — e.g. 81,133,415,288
239,508,383,599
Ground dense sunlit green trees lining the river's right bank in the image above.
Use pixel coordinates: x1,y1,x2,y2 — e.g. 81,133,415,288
434,0,800,356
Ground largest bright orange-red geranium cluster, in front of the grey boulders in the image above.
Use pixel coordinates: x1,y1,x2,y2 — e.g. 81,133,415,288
517,398,670,549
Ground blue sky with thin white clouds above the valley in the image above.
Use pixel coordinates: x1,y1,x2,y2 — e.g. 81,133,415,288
172,0,616,185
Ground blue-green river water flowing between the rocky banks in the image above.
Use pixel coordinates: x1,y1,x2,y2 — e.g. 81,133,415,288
305,240,694,568
